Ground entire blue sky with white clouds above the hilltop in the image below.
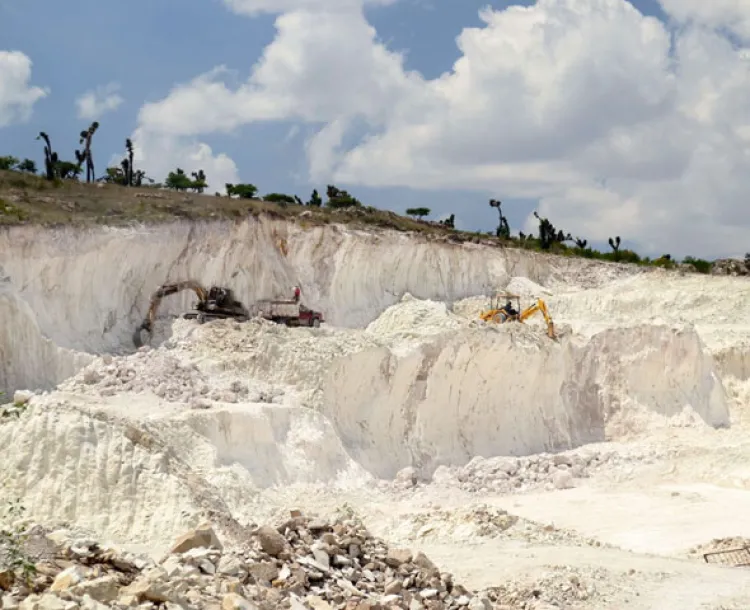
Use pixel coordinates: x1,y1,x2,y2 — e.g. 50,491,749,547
0,0,750,258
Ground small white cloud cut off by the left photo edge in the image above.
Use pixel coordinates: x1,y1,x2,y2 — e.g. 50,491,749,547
0,51,49,127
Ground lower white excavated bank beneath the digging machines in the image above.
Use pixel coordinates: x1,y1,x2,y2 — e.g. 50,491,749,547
0,297,728,544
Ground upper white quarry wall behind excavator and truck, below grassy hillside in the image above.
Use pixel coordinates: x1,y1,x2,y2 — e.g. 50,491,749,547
0,218,632,391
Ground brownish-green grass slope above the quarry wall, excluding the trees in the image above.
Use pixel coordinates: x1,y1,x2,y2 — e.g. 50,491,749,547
0,170,711,273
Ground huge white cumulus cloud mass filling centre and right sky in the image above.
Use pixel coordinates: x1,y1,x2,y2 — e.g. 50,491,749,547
132,0,750,255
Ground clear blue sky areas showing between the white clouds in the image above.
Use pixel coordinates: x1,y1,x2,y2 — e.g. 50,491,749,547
0,0,750,254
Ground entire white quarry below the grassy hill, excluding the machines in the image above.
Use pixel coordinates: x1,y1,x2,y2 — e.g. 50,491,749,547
0,210,750,610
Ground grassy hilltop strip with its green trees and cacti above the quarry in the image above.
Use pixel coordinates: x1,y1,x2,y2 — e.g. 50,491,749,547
0,122,732,273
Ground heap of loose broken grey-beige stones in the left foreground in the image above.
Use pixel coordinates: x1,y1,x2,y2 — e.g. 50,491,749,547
0,511,500,610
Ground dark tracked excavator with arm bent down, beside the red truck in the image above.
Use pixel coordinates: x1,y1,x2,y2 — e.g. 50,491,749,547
133,280,250,347
